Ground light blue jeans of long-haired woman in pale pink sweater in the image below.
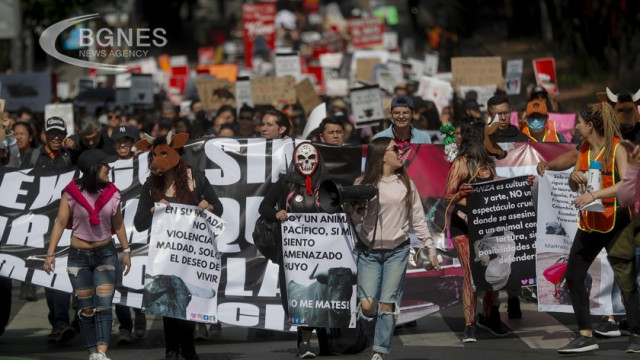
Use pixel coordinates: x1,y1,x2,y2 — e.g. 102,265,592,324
358,245,409,354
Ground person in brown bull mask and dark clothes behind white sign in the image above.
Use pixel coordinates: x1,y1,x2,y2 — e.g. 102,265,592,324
133,132,222,360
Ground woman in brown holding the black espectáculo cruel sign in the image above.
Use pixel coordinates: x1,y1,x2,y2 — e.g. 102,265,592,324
444,122,508,343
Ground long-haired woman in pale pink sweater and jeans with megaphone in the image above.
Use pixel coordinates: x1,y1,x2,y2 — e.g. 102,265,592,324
353,138,440,360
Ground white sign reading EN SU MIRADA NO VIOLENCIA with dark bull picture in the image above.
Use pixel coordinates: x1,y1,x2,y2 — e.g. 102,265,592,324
142,203,226,323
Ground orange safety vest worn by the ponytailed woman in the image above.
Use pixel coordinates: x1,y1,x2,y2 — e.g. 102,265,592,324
576,137,620,233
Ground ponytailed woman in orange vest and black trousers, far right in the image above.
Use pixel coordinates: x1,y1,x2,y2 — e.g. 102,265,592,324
558,102,640,354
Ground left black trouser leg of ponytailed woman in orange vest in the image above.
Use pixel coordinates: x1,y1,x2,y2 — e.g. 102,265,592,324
565,210,629,330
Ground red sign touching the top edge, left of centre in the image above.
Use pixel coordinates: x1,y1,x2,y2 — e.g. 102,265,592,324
242,1,276,68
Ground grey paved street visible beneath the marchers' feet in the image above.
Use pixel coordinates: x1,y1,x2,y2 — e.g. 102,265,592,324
0,282,638,360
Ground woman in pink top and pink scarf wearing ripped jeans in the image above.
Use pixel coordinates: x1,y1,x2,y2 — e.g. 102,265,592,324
44,149,131,360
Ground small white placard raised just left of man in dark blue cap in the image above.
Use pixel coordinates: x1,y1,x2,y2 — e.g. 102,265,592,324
349,85,384,129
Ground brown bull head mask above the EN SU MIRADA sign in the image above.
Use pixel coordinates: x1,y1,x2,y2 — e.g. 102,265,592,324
136,132,189,174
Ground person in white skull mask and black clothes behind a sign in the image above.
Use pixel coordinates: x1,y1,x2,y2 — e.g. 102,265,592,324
259,142,327,359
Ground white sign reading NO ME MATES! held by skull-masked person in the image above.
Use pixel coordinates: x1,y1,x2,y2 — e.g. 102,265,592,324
282,213,357,328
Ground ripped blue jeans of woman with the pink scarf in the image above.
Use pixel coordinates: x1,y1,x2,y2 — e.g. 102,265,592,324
67,242,118,352
